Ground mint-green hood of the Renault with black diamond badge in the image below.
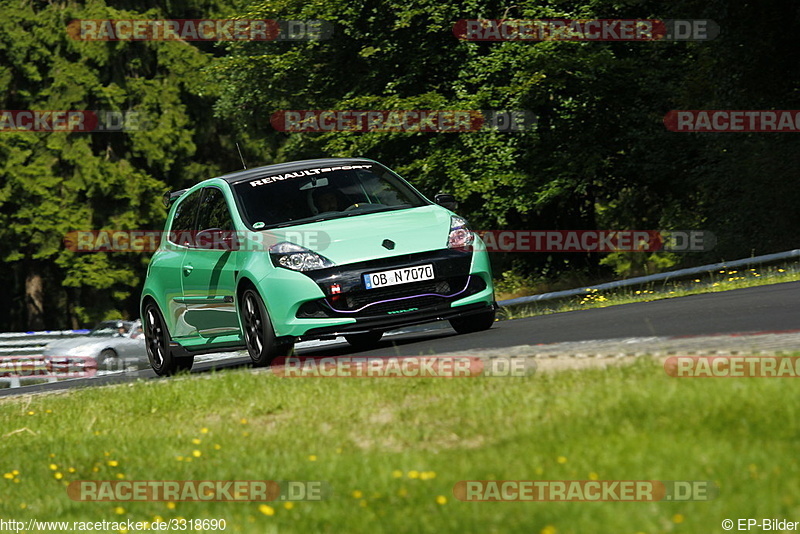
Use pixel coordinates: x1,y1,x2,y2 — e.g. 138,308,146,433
260,205,451,265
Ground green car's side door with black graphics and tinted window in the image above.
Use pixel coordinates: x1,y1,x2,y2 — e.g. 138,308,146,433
182,187,239,338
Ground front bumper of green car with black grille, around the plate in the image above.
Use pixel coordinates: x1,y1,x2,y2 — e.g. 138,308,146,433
255,248,496,340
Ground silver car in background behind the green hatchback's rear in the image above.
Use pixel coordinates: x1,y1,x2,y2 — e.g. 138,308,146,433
44,319,147,371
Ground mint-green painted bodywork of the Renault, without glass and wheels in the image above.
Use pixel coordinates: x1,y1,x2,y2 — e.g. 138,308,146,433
141,158,496,360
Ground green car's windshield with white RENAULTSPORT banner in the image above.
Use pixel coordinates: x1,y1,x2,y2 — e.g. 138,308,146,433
234,163,428,230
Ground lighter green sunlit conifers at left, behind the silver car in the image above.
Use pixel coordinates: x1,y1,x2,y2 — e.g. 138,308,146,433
0,0,253,330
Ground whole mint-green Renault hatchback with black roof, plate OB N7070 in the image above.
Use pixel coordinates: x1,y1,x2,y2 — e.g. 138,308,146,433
140,158,496,375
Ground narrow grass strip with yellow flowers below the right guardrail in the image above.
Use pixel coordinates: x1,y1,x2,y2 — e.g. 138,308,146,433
498,263,800,320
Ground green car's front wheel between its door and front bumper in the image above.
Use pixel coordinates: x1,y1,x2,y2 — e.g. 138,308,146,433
240,288,294,367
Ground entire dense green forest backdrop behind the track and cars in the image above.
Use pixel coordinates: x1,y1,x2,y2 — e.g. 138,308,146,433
0,0,800,330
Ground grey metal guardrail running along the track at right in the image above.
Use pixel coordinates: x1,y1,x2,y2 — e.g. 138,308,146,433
497,249,800,306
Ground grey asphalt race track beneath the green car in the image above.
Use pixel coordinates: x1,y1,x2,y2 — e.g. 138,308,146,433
0,282,800,396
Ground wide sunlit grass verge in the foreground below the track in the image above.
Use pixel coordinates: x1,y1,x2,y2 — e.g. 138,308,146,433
0,359,800,534
